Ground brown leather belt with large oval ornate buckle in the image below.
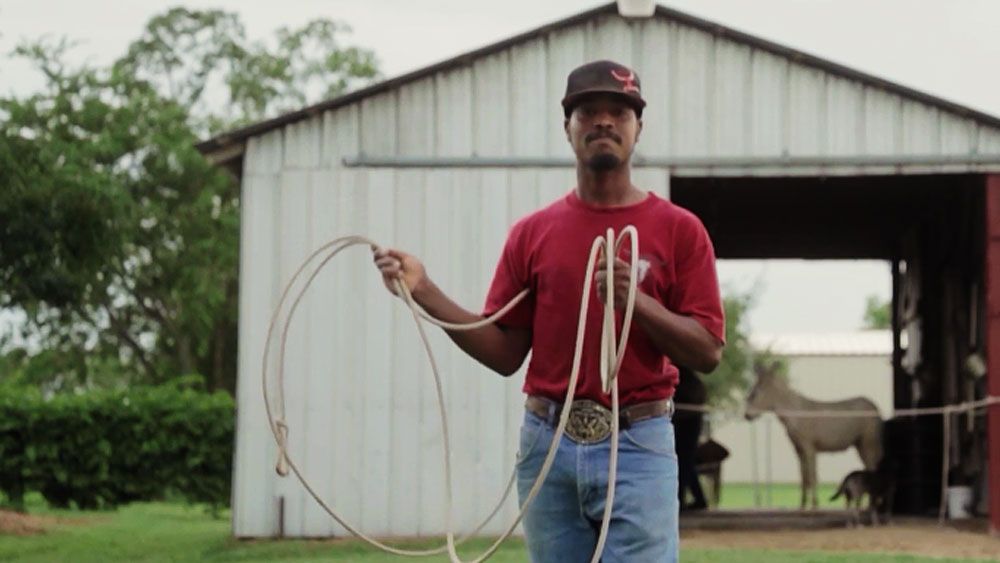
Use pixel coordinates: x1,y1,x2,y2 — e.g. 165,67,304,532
524,395,674,444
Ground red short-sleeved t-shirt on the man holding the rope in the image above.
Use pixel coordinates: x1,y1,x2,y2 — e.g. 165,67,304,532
484,191,725,406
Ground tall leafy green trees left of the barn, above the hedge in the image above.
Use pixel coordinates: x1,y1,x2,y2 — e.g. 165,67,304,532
0,8,377,390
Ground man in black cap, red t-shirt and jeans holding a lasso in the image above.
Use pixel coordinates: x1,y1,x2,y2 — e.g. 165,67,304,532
375,61,723,563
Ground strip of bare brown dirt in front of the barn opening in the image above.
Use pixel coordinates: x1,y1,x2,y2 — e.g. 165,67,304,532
681,521,1000,561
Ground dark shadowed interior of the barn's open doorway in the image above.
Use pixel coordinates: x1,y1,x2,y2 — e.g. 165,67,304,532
671,174,998,515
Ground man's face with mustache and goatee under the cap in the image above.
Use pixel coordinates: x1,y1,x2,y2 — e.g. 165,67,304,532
565,94,642,172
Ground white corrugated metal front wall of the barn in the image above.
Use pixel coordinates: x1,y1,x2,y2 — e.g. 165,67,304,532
233,9,1000,536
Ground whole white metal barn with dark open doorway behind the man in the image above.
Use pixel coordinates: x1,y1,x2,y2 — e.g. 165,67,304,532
199,4,1000,537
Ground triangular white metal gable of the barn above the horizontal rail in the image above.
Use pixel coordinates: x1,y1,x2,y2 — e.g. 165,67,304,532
200,4,1000,176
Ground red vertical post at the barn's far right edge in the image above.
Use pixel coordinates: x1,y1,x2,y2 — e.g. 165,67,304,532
985,174,1000,534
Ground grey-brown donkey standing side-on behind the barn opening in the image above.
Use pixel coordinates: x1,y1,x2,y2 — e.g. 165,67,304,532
746,362,882,510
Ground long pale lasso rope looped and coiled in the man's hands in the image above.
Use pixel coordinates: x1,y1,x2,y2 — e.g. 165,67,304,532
261,225,639,563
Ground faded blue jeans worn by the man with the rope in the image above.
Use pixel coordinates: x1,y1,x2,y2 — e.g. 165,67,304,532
517,412,678,563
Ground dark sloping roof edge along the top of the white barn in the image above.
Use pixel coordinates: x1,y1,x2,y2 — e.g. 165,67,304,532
197,3,1000,162
